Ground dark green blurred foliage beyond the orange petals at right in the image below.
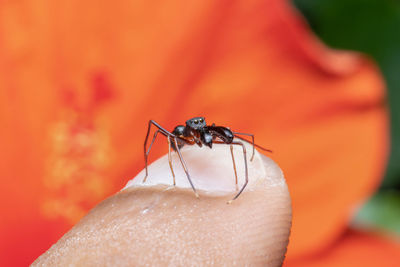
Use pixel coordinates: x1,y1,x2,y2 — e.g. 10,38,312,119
293,0,400,239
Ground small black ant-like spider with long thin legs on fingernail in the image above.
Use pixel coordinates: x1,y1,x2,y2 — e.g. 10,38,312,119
143,117,272,203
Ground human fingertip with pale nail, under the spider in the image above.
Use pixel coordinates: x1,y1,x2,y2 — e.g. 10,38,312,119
32,145,291,266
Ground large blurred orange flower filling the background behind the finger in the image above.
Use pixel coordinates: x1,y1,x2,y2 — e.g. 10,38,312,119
0,0,400,266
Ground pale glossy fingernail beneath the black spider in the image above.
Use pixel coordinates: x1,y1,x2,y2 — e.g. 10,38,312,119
123,142,285,198
